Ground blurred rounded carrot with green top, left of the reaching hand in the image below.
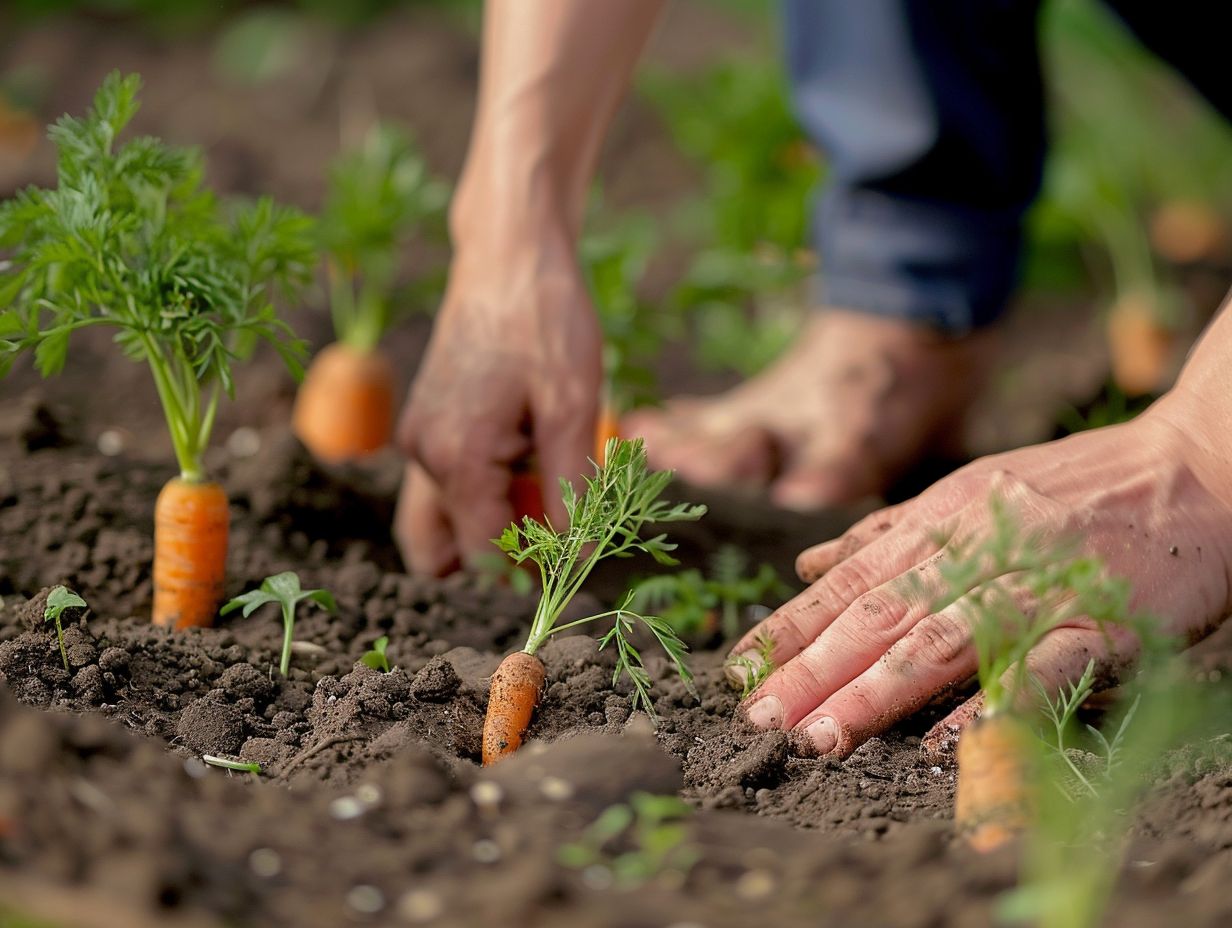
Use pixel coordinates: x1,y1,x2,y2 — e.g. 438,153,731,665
292,124,448,462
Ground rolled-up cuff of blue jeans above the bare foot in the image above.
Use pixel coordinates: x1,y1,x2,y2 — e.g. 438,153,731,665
816,189,1023,335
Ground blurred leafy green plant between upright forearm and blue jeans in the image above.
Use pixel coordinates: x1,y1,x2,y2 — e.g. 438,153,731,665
639,55,822,376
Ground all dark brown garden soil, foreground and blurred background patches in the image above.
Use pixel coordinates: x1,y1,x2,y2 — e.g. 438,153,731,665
0,4,1232,928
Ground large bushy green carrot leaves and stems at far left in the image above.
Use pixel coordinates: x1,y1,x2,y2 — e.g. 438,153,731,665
0,71,315,481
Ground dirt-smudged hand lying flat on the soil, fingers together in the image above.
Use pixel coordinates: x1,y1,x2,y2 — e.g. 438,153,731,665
733,401,1232,757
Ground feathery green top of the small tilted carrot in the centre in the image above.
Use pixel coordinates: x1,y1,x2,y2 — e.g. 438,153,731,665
496,439,706,715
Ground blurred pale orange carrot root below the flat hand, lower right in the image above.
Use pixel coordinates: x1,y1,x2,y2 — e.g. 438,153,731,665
954,714,1031,853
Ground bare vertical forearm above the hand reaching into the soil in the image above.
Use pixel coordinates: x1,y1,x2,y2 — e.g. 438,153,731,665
451,0,663,250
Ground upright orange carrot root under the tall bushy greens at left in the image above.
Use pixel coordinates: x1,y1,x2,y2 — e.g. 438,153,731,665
154,477,230,629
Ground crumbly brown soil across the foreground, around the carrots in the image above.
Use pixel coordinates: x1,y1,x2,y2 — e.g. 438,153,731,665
0,414,1232,928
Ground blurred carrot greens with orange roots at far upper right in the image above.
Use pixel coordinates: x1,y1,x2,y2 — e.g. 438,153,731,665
1027,0,1232,397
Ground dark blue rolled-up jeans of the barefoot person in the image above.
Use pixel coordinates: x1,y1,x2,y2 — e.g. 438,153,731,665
784,0,1232,334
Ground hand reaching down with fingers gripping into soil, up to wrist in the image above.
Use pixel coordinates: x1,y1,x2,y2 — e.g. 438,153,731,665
394,237,602,576
